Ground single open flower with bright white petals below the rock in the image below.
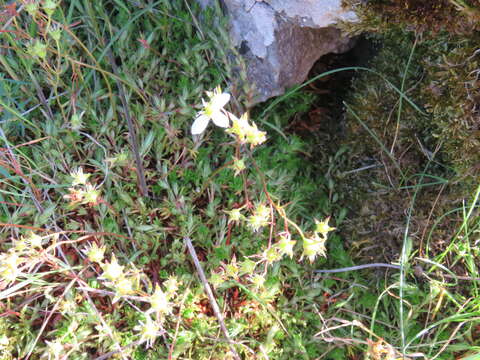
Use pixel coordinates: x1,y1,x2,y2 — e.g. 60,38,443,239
191,87,230,135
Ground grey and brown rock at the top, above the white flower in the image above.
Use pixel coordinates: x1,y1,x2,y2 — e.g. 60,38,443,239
198,0,356,103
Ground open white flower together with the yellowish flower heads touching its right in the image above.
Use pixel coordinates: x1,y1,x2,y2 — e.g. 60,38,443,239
191,87,267,148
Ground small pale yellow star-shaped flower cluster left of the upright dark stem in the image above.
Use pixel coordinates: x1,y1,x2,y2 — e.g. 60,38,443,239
63,168,101,206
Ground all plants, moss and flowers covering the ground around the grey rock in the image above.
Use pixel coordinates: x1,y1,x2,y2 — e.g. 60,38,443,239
0,0,480,359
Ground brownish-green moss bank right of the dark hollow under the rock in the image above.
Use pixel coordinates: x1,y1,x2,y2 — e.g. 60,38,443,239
332,0,480,259
